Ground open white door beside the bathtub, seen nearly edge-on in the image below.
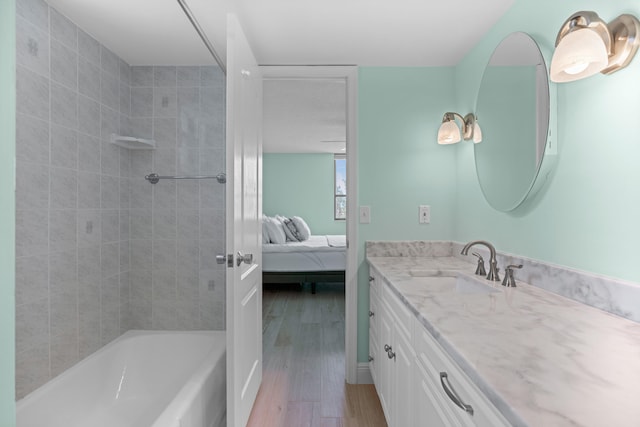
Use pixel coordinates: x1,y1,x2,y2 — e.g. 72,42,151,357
227,14,262,427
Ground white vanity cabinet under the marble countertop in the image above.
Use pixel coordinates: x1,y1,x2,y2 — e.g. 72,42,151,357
369,269,510,427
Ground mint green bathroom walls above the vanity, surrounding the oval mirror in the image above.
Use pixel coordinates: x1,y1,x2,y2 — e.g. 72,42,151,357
358,0,640,362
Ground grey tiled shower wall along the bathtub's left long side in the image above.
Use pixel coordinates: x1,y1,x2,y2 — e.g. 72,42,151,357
16,0,131,398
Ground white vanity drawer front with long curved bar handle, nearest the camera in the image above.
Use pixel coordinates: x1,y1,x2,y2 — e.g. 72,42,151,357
414,319,510,427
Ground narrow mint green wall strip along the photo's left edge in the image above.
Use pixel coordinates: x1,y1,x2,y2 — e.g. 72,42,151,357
0,0,16,427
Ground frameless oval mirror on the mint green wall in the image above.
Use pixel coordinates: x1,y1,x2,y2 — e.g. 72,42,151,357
474,32,553,212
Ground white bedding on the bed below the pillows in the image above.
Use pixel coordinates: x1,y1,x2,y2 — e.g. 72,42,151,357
262,235,347,272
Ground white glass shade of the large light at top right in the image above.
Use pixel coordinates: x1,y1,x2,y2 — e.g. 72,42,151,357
549,28,609,83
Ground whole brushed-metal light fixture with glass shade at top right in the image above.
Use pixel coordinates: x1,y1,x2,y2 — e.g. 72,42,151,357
549,11,640,83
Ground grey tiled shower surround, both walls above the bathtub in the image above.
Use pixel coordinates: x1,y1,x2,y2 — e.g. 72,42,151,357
16,0,225,398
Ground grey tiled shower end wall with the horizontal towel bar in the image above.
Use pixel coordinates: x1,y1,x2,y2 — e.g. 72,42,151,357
130,66,225,330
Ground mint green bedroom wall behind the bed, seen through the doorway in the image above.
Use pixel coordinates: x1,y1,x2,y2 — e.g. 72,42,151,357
262,153,346,234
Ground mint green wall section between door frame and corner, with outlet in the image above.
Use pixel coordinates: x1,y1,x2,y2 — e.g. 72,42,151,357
357,67,456,362
